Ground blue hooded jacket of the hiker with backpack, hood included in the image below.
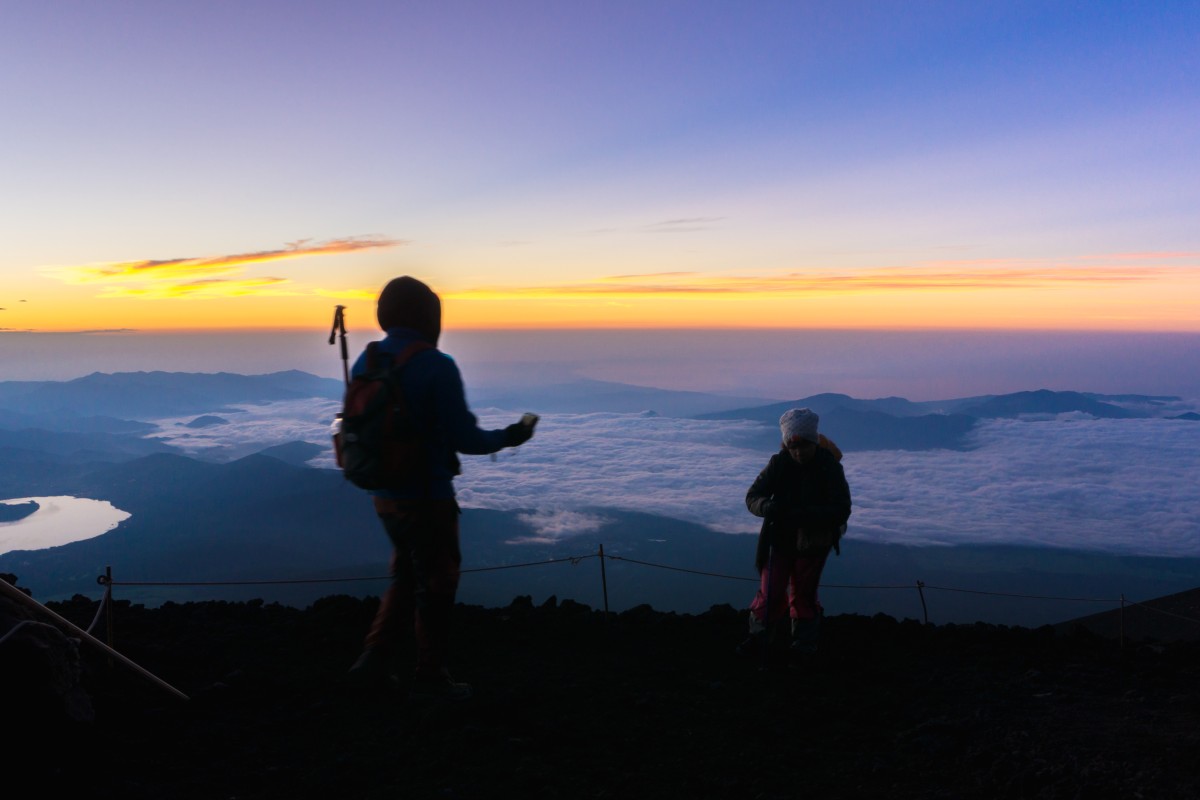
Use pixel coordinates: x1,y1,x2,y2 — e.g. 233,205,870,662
350,277,509,499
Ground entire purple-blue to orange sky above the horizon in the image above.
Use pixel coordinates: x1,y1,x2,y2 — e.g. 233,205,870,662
0,0,1200,332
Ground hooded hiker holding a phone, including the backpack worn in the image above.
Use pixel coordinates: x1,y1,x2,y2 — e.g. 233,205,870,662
345,276,536,699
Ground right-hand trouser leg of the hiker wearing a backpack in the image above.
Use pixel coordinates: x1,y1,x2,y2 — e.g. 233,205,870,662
413,500,462,675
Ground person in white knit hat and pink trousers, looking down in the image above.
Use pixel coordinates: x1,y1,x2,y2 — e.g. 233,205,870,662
738,408,850,657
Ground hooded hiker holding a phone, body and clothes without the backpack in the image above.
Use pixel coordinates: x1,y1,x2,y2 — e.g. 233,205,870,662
350,276,533,699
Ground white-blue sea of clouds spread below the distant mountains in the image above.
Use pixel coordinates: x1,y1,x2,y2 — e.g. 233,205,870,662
150,399,1200,557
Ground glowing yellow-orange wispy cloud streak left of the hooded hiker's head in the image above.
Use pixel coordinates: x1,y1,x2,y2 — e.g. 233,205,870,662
42,236,406,300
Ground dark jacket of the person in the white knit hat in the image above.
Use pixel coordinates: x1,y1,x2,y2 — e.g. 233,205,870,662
746,447,850,571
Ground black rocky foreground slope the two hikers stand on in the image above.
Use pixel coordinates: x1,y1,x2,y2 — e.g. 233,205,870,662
6,596,1200,800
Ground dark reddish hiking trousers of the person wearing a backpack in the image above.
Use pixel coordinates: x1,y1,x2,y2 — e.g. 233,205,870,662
366,498,462,675
